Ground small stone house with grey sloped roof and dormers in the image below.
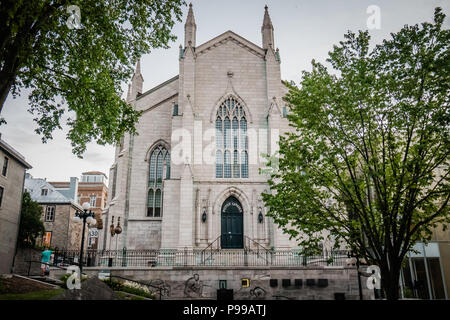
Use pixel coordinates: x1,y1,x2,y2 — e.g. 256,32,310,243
25,174,88,250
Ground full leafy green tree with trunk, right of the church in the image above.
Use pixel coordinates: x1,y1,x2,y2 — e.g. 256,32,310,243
263,8,450,299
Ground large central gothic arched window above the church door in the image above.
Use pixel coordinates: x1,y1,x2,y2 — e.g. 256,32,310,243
216,97,248,178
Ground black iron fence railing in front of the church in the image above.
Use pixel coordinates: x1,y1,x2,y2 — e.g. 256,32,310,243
53,249,348,267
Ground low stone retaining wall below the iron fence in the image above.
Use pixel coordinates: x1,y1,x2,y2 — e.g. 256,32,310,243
51,267,374,300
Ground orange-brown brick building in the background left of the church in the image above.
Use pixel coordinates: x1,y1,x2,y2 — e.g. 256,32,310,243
50,171,108,249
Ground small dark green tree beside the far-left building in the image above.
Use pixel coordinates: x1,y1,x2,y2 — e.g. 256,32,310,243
17,191,45,247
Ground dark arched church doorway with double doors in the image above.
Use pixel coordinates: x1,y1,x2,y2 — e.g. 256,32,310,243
221,197,244,249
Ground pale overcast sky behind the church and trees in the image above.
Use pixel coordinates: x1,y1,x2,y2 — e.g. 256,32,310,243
0,0,450,181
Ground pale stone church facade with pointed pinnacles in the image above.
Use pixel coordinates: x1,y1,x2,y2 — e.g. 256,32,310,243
104,3,296,249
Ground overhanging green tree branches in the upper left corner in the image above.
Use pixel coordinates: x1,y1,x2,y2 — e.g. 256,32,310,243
0,0,185,156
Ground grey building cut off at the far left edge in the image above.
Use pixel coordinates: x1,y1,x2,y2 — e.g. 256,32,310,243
0,135,31,274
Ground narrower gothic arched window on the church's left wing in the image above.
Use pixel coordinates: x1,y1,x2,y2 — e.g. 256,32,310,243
147,145,170,217
